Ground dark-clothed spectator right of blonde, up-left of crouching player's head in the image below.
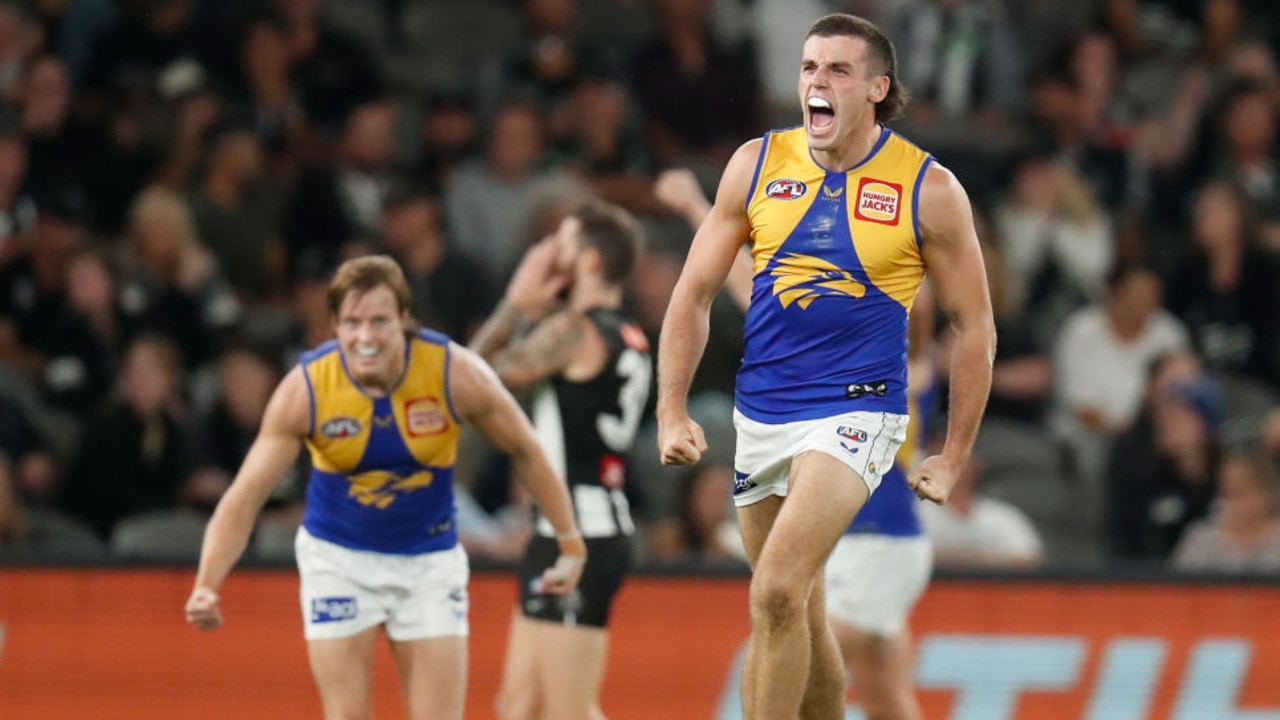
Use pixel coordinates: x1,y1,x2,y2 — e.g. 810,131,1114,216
191,129,284,306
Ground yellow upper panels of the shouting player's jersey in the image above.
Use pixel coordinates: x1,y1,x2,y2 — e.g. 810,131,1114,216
748,128,929,310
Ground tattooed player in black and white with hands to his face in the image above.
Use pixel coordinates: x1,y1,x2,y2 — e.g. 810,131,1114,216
472,201,653,720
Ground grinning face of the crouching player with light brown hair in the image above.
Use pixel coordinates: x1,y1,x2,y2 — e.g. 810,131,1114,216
334,286,410,391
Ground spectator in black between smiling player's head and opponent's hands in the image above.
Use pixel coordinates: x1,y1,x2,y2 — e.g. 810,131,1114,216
383,184,497,343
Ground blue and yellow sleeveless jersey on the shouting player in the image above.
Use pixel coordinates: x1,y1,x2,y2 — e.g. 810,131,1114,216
736,128,933,423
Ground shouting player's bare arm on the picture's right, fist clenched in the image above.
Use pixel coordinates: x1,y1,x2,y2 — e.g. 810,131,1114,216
909,164,996,502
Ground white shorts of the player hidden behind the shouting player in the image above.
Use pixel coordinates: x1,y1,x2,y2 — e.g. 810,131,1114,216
827,534,933,635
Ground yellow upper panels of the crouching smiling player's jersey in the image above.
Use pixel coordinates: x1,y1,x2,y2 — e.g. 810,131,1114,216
305,336,458,476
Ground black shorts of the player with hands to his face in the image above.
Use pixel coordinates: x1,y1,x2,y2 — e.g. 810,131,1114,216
518,536,631,628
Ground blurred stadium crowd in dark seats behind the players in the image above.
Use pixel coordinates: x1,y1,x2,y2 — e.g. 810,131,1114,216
0,0,1280,573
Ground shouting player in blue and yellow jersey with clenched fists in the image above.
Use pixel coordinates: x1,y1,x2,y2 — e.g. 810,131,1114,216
657,14,996,720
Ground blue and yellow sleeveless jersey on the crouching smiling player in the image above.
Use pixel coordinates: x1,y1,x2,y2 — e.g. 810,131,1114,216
301,331,458,555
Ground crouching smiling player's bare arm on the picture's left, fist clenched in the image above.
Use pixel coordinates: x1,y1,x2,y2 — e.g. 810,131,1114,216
187,365,311,630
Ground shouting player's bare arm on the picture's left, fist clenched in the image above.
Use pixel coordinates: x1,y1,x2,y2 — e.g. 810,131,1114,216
658,138,762,465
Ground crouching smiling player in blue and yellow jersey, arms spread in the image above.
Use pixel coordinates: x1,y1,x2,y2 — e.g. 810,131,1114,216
187,256,586,720
